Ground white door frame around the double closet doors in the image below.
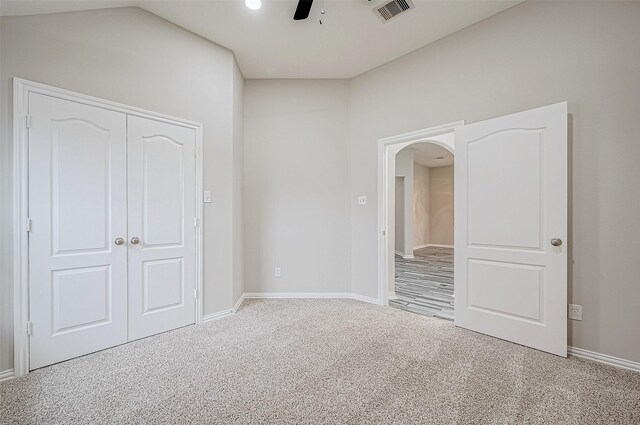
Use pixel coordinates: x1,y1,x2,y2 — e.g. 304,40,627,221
13,77,204,377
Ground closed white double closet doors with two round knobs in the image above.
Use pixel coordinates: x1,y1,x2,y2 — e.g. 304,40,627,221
28,93,196,369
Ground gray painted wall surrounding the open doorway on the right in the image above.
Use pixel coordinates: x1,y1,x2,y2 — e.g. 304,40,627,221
350,2,640,362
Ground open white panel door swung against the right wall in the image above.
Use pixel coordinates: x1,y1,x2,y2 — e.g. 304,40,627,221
455,102,567,357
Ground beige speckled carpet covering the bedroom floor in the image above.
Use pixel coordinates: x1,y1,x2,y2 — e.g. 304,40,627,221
0,300,640,425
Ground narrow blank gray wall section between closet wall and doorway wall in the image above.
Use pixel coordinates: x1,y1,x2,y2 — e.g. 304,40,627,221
244,80,350,292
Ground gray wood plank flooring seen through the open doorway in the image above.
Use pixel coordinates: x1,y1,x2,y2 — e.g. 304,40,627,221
389,247,453,320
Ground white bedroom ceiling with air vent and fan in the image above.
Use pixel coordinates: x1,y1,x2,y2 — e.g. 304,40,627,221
0,0,522,78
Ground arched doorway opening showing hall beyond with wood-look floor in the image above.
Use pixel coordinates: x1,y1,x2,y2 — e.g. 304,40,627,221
388,141,454,320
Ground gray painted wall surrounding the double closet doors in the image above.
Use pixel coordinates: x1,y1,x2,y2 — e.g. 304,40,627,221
0,8,243,371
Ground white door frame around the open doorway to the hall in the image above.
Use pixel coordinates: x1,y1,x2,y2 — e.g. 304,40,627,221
378,120,464,305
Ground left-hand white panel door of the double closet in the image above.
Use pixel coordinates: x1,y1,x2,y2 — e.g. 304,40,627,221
29,93,127,369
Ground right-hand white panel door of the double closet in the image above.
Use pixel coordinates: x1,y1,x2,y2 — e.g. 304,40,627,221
128,116,196,340
